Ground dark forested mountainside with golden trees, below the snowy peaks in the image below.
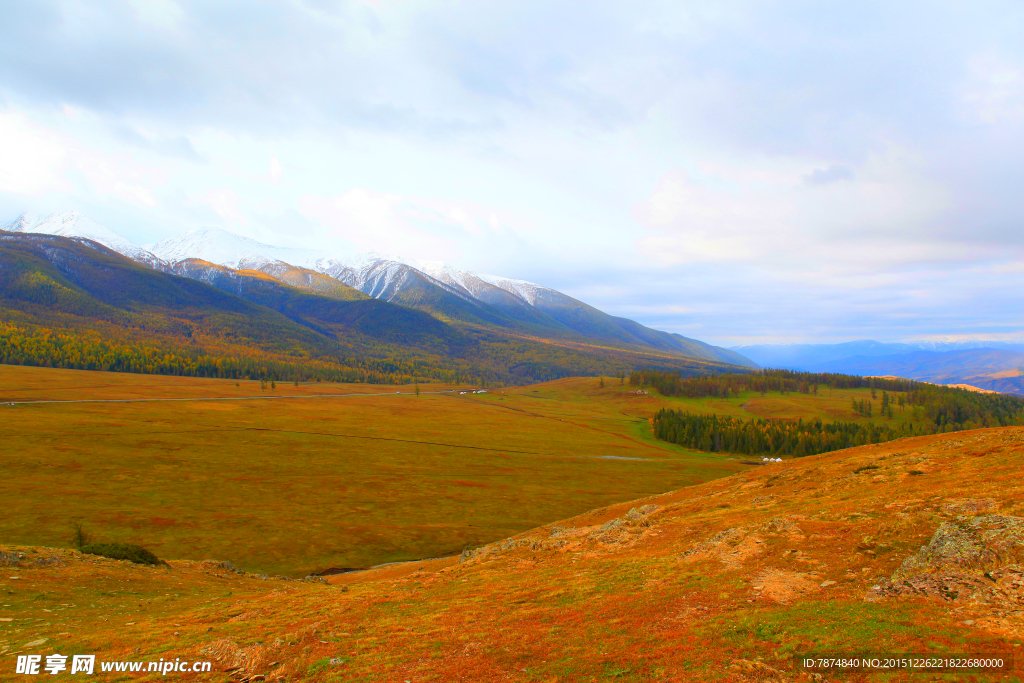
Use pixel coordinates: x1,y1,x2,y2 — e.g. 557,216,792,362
0,233,736,384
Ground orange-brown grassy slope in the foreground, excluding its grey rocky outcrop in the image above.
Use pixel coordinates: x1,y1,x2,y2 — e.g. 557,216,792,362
0,428,1024,682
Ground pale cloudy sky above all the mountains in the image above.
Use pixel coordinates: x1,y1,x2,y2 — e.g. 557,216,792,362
0,0,1024,345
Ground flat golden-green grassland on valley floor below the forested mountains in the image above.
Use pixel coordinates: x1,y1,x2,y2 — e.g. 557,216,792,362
0,366,744,575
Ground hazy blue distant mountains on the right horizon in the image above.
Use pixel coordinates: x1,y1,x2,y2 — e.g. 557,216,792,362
733,340,1024,394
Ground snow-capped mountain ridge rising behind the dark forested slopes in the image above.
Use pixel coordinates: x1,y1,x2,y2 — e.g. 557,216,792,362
5,212,754,366
